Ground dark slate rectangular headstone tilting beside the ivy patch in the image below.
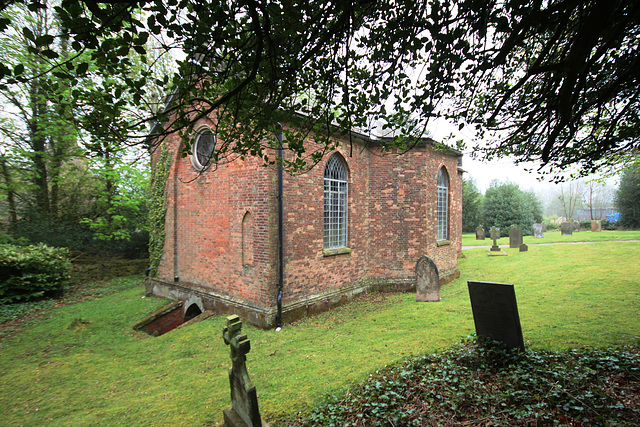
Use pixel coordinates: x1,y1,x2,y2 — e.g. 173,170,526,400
467,281,524,351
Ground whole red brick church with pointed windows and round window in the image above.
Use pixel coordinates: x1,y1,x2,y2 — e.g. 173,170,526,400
146,124,463,328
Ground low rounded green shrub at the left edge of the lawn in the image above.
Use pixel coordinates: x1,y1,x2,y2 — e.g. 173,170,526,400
0,244,71,304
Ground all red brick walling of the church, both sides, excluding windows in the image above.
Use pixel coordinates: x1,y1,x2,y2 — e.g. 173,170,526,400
157,123,462,324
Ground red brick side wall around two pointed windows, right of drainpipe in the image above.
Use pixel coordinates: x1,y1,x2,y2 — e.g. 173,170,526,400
284,136,462,302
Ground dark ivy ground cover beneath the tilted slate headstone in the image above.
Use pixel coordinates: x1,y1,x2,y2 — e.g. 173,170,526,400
294,338,640,426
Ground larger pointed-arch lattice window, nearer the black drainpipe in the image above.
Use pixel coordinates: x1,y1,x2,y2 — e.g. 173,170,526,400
323,153,349,250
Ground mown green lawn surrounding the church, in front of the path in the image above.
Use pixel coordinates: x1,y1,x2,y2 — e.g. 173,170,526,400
0,239,640,425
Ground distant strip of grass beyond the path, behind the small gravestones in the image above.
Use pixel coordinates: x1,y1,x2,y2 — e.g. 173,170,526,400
462,230,640,246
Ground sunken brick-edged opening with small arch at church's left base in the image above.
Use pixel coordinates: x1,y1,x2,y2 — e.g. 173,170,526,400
133,301,213,337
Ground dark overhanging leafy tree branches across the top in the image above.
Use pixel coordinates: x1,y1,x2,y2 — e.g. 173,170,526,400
0,0,640,173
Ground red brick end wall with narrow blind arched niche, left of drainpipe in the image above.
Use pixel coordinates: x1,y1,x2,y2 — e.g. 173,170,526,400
157,123,277,305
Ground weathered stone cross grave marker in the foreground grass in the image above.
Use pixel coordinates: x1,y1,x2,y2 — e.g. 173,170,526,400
222,314,262,427
